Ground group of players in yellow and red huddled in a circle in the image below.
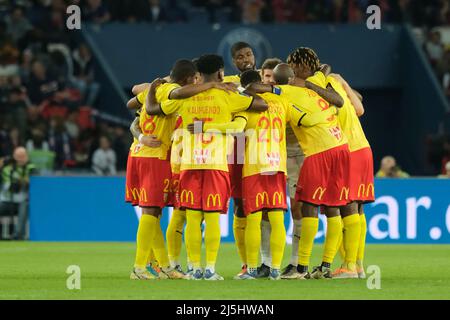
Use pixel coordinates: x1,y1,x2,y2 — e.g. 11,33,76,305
126,42,374,280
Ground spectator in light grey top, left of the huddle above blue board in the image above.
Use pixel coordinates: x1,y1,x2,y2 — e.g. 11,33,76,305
92,136,117,176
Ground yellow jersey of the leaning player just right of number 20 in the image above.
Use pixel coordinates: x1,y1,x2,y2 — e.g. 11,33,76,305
280,85,348,157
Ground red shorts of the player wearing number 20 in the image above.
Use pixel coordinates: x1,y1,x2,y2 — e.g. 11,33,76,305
242,172,287,215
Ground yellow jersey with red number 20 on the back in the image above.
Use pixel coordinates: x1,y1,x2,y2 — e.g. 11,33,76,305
235,93,290,177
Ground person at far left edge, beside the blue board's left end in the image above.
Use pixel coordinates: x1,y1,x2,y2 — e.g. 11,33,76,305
0,147,35,240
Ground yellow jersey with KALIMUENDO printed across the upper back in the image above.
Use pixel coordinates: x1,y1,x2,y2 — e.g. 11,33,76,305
161,89,253,172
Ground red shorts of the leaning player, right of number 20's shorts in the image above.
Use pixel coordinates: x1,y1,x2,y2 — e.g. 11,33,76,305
295,144,350,207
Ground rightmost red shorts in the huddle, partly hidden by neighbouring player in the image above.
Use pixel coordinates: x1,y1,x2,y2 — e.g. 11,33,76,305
350,148,375,202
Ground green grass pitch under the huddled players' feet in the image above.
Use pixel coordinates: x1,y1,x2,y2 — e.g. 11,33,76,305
0,242,450,300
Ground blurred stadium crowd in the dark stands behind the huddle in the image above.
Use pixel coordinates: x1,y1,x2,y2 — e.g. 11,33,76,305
0,0,450,175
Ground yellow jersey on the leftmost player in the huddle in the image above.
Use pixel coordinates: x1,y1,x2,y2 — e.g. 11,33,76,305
130,83,180,160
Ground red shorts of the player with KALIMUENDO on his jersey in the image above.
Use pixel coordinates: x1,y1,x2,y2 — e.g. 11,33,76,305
179,170,231,214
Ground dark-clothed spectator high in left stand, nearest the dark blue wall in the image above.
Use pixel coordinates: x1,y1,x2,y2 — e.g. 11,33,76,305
73,43,100,106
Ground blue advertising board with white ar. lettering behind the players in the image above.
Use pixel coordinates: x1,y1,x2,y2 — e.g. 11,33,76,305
30,177,450,244
